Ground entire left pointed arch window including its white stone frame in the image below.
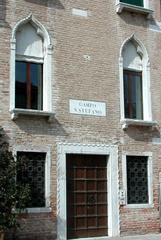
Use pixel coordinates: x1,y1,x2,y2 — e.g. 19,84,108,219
10,15,52,120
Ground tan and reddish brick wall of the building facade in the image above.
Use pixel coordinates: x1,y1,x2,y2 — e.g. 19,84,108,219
0,0,161,239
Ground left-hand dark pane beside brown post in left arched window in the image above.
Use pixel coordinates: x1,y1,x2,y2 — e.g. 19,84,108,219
15,62,27,108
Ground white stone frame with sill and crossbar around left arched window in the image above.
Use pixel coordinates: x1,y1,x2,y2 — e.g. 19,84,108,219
9,14,53,120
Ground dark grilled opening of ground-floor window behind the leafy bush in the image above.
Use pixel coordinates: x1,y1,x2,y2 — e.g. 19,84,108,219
17,152,46,208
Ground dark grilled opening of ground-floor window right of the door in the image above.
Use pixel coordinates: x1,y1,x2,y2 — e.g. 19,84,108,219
127,156,148,204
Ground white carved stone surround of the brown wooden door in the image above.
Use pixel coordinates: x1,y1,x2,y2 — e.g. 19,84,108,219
57,143,120,240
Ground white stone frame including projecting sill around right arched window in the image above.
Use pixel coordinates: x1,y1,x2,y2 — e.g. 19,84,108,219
119,34,157,130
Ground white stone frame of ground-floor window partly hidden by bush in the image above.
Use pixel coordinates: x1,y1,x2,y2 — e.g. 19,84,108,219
13,146,51,213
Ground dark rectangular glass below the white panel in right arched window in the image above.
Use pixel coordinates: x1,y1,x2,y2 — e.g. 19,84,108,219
124,70,143,119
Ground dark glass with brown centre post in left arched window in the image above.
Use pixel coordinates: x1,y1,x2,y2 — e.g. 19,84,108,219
15,61,43,110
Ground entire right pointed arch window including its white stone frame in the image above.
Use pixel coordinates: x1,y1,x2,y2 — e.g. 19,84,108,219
120,36,154,128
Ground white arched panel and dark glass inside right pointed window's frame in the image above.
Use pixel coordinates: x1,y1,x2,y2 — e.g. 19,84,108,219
123,41,143,119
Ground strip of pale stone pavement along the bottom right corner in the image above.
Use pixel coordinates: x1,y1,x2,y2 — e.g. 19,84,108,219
109,233,161,240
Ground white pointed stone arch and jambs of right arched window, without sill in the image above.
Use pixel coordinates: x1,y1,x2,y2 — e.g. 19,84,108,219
119,34,152,127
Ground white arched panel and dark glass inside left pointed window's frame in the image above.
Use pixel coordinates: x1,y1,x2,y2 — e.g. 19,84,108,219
15,23,44,110
